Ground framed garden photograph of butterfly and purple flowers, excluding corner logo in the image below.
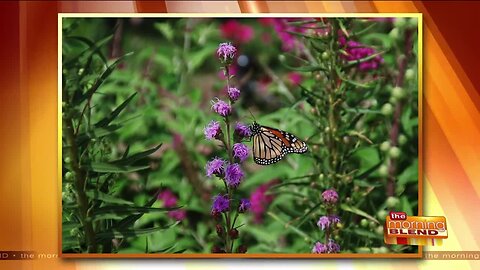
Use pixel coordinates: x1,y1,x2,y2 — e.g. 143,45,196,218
58,13,422,259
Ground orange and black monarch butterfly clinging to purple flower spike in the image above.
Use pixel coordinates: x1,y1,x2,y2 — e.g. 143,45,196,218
250,122,308,165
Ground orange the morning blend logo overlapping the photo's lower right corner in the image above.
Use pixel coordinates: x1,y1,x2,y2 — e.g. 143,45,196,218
384,212,448,246
